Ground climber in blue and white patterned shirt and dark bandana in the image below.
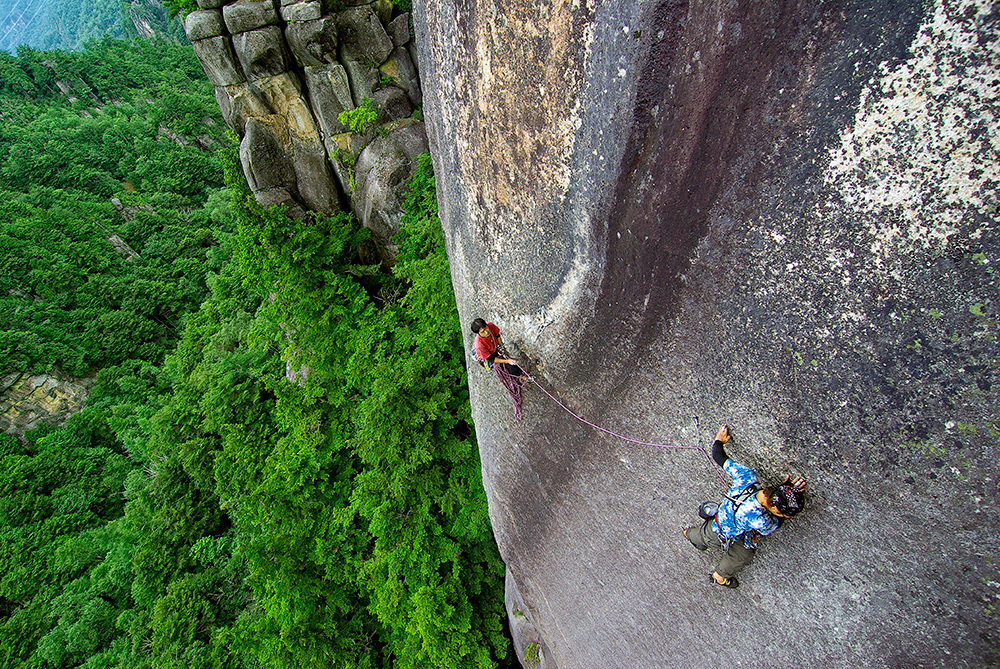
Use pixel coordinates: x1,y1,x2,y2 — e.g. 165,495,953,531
684,425,806,588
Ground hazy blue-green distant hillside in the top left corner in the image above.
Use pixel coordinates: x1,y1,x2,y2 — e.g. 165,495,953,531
0,0,183,53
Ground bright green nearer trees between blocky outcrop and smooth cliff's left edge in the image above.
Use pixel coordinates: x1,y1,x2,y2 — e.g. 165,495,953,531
224,149,506,667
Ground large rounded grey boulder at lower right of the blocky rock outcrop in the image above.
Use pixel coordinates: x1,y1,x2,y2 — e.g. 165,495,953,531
351,122,427,263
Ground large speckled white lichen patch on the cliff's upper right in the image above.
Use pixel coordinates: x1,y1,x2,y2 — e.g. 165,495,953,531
825,0,1000,261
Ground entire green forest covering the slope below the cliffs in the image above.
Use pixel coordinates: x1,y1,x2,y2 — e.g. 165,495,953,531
0,35,516,668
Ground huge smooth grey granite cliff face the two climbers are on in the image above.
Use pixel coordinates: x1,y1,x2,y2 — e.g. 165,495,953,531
413,0,1000,669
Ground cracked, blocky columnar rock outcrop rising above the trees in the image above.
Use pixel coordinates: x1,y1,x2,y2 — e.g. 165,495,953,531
184,0,427,261
